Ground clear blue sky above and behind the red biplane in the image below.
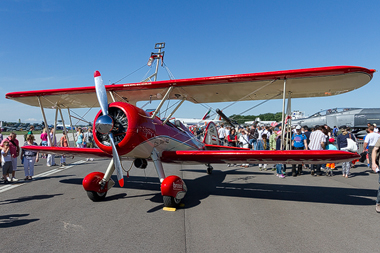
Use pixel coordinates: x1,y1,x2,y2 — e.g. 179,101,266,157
0,0,380,122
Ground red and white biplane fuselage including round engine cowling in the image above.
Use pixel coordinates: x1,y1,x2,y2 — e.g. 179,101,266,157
93,102,205,158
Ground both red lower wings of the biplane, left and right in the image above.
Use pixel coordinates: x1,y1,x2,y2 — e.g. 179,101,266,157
22,146,360,164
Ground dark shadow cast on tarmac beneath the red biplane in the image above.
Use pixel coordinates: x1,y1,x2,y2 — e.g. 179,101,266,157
60,168,377,212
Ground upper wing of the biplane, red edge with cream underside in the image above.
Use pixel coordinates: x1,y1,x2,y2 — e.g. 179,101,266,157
6,66,375,108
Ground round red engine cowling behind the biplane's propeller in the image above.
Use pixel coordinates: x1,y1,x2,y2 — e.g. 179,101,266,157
93,102,155,155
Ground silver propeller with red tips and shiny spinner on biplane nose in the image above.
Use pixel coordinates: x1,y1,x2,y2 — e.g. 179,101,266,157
94,71,124,187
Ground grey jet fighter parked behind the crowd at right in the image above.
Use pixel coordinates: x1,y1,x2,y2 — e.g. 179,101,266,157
292,108,380,129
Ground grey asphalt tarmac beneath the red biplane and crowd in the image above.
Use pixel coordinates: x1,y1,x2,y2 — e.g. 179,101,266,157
0,158,380,253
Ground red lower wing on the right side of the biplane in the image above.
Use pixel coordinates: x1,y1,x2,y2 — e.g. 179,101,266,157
161,150,360,164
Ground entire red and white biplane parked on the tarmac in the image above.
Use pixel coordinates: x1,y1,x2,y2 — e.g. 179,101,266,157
6,49,375,206
